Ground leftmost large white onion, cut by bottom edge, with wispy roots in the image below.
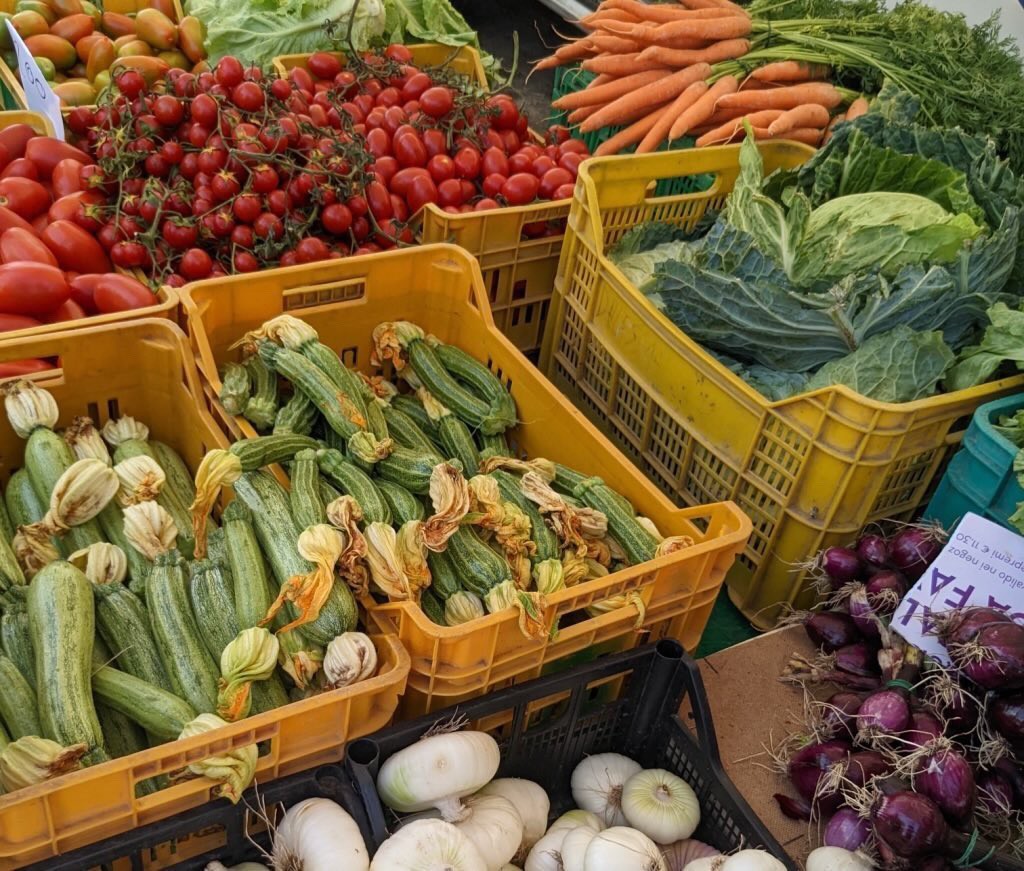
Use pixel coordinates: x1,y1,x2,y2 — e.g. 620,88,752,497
271,798,370,871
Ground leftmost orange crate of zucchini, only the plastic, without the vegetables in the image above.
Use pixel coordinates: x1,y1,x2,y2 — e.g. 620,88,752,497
0,319,409,871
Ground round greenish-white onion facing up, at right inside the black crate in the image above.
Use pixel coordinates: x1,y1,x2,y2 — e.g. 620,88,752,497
622,769,700,843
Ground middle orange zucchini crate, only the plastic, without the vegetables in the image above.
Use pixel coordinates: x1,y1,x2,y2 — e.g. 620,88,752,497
182,245,750,713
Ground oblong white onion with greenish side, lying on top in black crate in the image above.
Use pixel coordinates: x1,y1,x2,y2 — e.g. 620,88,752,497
377,732,501,822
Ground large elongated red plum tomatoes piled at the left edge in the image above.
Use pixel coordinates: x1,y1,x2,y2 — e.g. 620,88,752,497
0,118,156,360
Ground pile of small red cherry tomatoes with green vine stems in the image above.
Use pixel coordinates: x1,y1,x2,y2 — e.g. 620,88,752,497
68,45,587,287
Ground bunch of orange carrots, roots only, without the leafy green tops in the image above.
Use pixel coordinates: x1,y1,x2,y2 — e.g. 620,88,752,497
535,0,867,155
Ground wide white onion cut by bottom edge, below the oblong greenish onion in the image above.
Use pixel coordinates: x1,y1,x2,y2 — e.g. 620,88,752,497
370,820,487,871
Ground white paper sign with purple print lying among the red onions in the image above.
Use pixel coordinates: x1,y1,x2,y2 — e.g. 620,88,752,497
892,512,1024,665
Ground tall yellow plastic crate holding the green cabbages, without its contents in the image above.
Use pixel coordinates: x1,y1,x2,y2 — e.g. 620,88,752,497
541,142,1024,627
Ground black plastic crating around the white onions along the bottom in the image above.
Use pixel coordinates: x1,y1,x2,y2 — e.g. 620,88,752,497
33,640,782,871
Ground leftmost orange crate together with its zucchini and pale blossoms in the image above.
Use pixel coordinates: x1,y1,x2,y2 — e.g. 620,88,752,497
0,320,409,867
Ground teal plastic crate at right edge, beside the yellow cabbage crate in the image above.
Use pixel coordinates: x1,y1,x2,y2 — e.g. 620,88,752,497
924,393,1024,529
